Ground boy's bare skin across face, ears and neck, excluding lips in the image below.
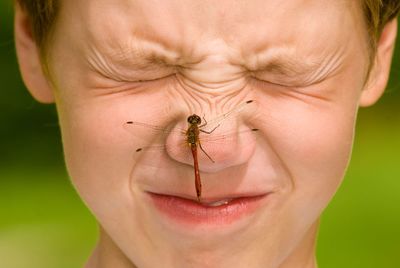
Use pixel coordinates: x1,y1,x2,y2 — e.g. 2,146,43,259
15,0,397,268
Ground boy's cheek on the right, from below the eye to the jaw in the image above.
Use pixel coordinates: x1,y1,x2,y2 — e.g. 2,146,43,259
247,93,357,246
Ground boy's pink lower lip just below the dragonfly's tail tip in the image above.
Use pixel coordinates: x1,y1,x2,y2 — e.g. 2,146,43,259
149,193,267,225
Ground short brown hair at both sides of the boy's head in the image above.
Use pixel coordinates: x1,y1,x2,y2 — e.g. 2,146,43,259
16,0,400,55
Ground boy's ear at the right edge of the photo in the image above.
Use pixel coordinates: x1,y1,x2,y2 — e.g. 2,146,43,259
360,19,397,107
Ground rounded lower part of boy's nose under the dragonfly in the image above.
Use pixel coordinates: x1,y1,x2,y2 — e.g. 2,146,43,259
166,114,258,173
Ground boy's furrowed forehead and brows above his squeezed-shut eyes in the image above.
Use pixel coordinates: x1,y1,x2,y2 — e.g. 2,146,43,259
55,0,356,73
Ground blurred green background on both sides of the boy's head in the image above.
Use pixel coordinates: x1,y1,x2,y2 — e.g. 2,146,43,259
0,0,400,268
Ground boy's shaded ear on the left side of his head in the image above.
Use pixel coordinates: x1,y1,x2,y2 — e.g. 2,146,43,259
14,4,54,103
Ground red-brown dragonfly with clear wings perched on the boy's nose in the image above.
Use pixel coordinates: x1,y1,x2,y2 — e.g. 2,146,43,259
124,100,258,203
